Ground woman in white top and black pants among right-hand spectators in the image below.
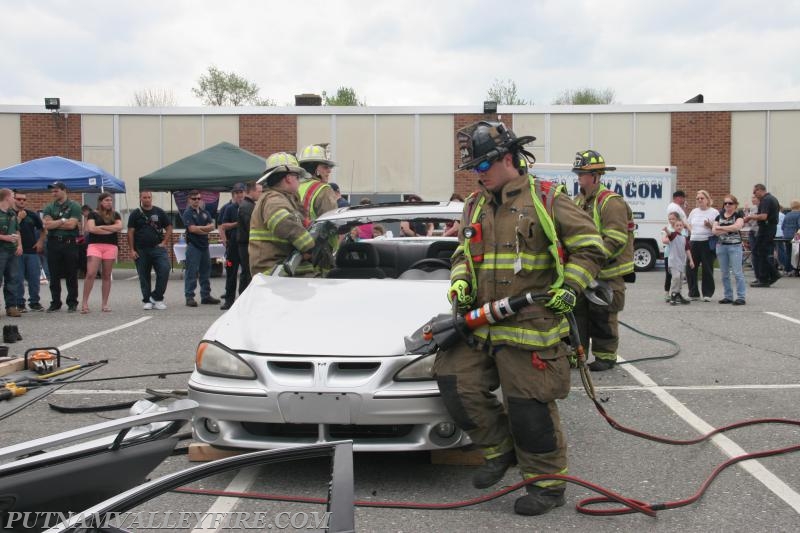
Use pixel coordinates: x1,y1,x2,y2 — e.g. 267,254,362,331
686,190,719,302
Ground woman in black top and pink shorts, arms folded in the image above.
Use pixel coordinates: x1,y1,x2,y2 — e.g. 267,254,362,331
81,192,122,315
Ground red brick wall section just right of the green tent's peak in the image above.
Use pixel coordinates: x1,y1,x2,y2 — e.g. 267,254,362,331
239,115,297,157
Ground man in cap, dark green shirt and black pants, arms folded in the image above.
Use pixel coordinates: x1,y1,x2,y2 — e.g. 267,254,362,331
42,181,82,313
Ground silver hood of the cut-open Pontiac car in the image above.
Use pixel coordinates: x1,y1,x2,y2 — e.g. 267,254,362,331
204,275,450,357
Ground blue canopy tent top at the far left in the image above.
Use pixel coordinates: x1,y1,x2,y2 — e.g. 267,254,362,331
0,156,125,193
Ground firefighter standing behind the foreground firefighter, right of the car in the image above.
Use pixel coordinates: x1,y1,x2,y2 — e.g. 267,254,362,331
572,150,635,372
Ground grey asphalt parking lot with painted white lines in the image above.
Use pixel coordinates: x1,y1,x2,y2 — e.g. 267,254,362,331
0,264,800,532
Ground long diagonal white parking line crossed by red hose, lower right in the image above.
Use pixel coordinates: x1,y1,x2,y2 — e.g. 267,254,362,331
619,357,800,513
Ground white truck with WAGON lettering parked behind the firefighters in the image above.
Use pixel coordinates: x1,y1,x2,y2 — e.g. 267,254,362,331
531,163,678,271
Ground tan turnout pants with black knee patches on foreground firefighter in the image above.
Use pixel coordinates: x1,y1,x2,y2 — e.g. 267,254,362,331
434,342,570,485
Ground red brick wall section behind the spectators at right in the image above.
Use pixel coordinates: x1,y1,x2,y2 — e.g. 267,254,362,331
670,111,731,207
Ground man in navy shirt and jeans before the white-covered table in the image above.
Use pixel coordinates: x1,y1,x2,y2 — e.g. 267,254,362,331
183,190,219,307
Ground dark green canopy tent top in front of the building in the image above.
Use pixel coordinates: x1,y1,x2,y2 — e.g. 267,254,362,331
139,142,266,191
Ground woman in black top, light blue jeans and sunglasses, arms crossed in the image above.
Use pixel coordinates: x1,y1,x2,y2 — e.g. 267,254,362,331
712,194,745,305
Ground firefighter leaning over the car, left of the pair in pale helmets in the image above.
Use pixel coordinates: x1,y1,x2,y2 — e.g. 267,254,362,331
247,152,315,277
